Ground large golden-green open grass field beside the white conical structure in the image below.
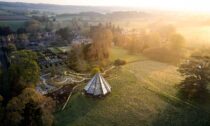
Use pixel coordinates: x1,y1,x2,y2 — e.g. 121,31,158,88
55,48,210,126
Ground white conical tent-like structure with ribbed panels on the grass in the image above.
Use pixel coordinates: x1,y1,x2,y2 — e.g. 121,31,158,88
84,73,111,96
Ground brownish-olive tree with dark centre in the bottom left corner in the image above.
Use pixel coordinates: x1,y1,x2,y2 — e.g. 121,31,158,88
5,88,55,126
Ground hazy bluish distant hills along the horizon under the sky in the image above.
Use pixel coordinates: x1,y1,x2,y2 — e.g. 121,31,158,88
0,2,140,14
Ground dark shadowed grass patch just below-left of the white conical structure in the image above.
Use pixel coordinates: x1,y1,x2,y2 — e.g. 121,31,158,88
55,92,100,126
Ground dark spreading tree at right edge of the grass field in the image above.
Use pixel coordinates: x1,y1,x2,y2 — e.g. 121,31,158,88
178,55,210,98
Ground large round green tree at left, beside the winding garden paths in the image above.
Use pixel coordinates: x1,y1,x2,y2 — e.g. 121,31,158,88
9,50,40,96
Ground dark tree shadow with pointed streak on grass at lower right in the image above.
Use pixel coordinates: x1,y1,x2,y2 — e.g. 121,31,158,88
148,87,210,126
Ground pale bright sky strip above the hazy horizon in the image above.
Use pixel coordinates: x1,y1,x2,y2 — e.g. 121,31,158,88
1,0,210,12
